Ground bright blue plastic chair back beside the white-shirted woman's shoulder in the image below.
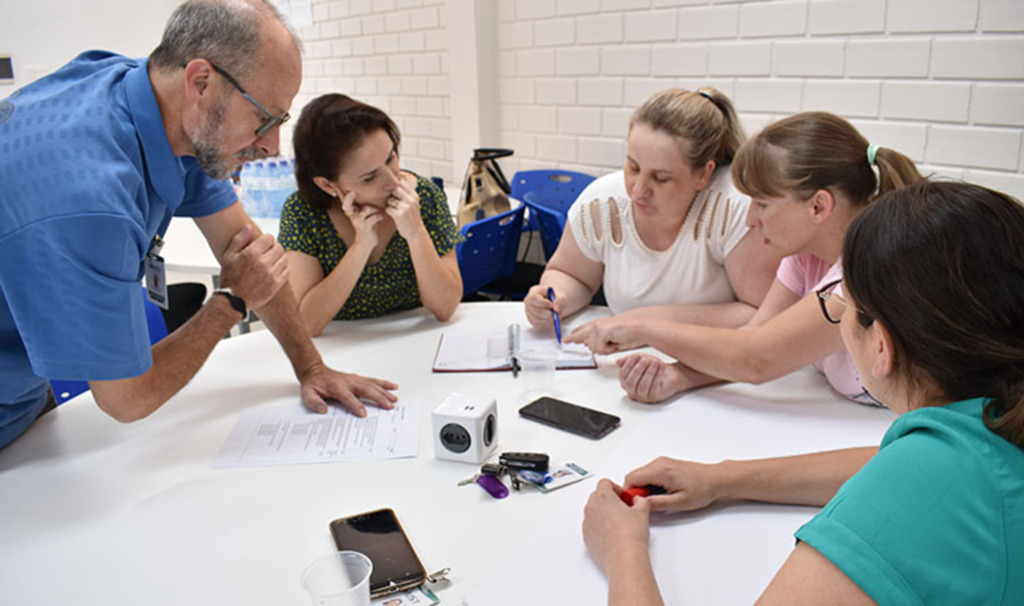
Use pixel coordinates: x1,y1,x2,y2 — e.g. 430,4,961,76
512,170,594,259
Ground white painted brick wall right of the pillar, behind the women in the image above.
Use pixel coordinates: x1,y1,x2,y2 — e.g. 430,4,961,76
487,0,1024,199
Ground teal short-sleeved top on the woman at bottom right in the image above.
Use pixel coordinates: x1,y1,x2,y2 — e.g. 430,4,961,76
797,398,1024,604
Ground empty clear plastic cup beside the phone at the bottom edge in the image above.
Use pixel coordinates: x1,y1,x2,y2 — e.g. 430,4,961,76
302,552,374,606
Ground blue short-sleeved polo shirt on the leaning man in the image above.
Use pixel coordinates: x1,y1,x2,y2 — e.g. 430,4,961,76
0,51,236,446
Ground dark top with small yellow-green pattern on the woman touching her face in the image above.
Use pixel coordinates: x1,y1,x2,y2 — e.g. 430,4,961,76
278,175,462,319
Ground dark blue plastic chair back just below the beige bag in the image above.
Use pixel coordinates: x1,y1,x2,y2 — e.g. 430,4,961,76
456,206,526,297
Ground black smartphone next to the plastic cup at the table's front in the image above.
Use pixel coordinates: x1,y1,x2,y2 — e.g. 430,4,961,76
331,509,427,598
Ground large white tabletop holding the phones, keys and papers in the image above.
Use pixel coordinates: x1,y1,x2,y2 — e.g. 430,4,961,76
0,303,891,606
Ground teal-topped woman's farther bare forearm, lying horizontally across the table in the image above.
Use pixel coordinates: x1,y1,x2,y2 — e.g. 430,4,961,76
716,446,879,507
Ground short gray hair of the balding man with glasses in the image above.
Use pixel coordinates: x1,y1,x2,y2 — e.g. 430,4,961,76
150,0,302,80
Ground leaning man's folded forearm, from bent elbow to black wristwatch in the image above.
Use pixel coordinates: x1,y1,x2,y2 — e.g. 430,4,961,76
89,297,240,423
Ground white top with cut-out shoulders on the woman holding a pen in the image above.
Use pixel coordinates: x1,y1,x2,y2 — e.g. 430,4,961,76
568,166,751,313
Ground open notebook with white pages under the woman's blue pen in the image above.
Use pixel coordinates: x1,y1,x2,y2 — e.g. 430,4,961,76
434,324,597,373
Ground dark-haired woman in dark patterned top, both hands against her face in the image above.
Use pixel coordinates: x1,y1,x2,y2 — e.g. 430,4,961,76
278,94,462,335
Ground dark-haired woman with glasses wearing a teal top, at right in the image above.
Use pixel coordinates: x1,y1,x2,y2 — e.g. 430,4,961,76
584,181,1024,605
